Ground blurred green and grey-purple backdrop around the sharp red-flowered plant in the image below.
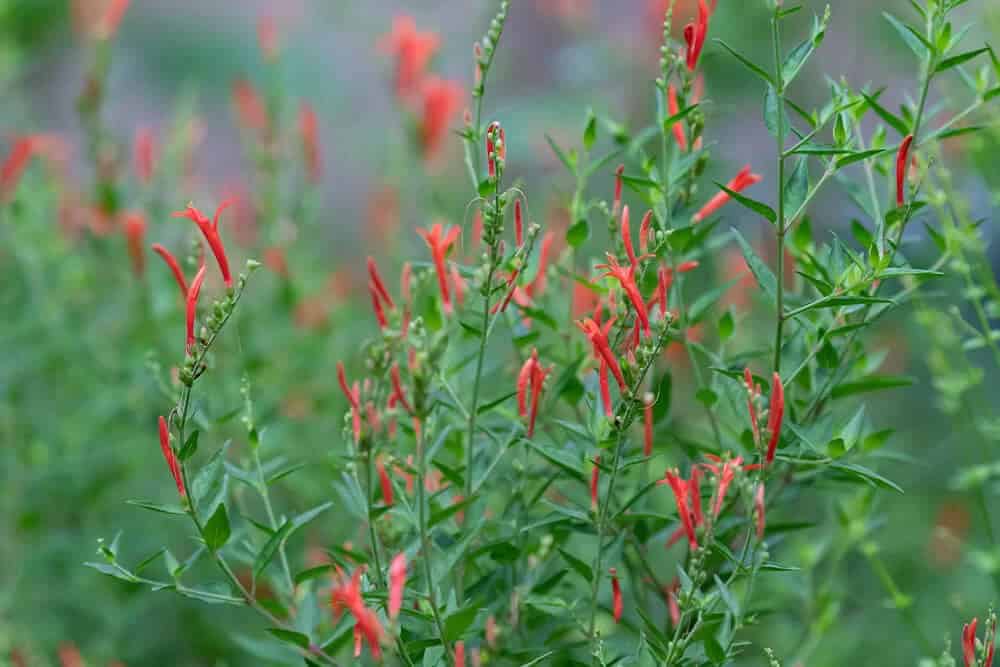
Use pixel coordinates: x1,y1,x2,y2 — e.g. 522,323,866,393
0,0,1000,666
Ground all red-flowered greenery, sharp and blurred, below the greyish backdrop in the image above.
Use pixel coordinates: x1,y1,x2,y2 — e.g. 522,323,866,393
0,0,1000,667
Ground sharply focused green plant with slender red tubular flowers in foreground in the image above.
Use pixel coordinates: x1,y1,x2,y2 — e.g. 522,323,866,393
74,0,1000,667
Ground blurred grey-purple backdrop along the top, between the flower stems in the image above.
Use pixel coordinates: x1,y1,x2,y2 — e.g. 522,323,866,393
15,0,988,250
